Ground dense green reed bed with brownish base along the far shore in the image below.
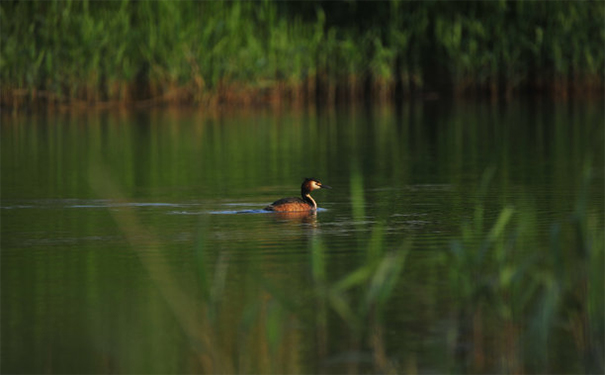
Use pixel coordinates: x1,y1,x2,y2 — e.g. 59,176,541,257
0,0,605,107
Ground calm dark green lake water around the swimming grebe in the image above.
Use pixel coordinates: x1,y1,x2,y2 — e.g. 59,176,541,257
0,99,604,374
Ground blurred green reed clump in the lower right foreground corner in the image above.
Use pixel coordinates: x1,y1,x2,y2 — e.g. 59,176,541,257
444,169,605,373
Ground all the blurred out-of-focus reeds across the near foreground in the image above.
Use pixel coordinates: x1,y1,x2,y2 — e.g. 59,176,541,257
91,165,604,373
